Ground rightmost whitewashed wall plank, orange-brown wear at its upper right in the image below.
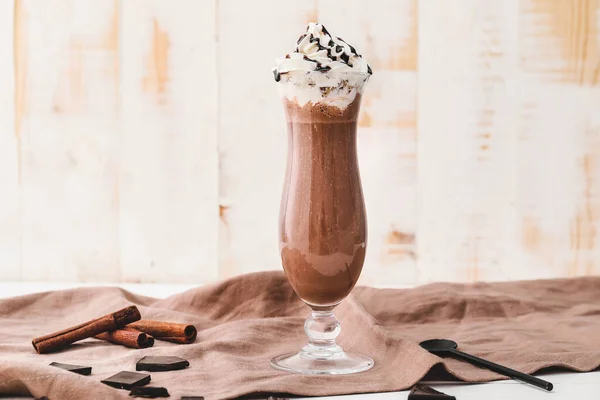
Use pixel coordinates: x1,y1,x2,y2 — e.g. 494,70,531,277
513,0,600,277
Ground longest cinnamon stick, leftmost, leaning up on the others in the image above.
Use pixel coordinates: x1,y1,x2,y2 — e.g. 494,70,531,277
31,306,141,354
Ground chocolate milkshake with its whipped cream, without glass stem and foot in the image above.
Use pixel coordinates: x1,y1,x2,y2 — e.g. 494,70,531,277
274,24,371,308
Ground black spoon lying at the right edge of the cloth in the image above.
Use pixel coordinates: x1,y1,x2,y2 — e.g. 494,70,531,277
419,339,554,391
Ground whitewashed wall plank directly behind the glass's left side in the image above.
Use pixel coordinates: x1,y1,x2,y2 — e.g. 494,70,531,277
217,0,317,277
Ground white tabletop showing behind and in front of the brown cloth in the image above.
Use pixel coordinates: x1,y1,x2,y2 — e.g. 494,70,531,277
0,282,600,400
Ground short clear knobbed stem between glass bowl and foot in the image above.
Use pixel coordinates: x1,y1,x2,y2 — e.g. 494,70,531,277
302,310,344,358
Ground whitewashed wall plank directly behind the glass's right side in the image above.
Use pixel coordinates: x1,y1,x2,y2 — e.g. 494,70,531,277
319,0,418,285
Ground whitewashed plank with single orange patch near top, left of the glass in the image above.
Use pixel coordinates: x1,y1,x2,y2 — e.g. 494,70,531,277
119,0,219,283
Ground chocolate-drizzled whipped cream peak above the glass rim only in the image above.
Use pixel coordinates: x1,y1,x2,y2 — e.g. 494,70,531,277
273,22,373,82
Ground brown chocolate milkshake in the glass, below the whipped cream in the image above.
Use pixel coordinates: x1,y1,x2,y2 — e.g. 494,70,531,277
279,86,367,307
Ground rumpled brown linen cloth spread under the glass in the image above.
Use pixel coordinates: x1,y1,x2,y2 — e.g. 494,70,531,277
0,272,600,400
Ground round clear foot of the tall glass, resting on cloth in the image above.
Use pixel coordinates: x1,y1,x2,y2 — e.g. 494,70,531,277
271,349,374,375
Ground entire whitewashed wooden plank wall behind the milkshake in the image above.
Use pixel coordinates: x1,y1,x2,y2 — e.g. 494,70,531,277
0,0,600,286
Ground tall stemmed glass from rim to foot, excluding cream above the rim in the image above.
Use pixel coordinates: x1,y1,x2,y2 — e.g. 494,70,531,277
271,71,373,374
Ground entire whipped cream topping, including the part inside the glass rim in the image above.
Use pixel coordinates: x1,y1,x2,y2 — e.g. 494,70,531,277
273,22,373,110
